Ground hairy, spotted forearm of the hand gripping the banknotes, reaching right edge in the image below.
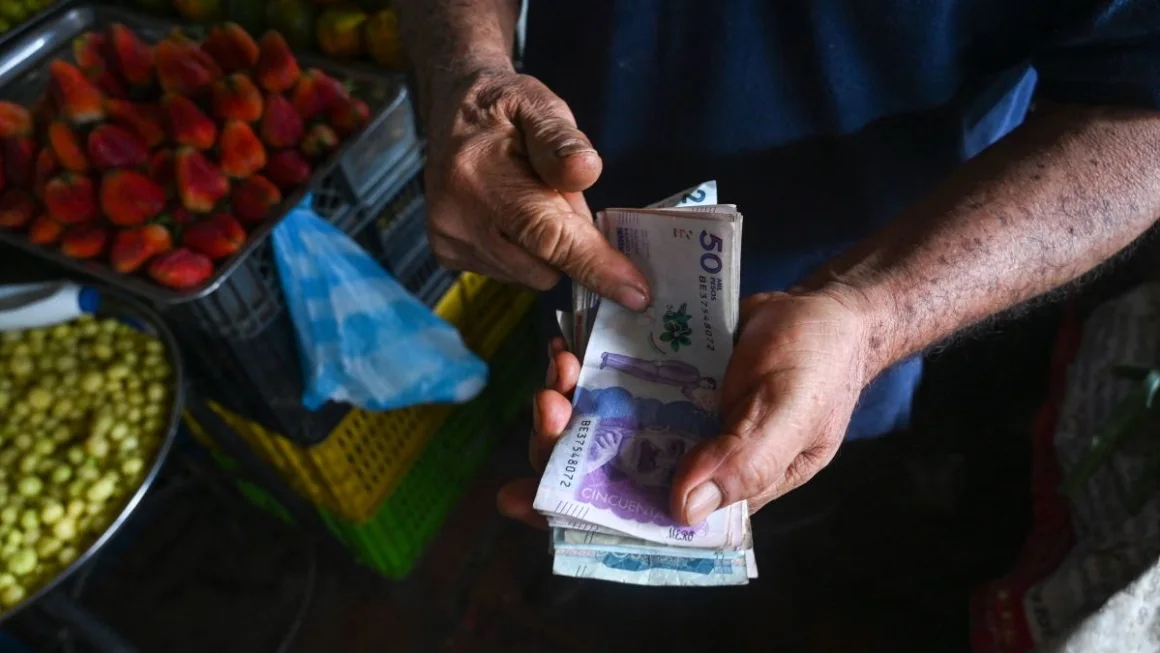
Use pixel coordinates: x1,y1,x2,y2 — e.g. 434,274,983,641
806,107,1160,376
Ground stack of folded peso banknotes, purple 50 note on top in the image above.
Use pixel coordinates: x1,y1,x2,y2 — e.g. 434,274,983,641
535,182,757,586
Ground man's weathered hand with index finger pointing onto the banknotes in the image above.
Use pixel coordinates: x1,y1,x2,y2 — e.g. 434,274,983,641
427,70,650,311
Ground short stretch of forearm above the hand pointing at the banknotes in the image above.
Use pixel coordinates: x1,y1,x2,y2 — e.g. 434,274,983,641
391,0,520,116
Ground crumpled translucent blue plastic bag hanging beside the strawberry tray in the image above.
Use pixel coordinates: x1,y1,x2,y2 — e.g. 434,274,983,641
274,195,487,411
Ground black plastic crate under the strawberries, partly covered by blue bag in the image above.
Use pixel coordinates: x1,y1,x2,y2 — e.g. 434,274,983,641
167,156,455,444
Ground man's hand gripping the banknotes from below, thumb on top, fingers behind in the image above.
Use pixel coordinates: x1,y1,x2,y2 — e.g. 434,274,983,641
499,293,871,525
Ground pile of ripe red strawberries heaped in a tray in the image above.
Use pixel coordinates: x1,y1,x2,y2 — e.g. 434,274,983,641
0,23,368,289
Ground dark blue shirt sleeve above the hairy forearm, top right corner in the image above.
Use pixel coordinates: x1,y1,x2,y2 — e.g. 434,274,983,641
1034,0,1160,109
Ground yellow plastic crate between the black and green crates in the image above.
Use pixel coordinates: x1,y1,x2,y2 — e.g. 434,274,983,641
186,274,535,523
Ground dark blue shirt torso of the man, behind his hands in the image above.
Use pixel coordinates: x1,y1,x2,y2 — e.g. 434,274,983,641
524,0,1160,437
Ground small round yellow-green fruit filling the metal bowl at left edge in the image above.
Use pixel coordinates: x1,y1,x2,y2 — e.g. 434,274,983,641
0,317,173,609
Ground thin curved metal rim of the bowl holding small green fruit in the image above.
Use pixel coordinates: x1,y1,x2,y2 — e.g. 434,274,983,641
0,288,186,624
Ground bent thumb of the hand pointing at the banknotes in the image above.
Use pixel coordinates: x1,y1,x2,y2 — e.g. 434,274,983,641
516,89,603,193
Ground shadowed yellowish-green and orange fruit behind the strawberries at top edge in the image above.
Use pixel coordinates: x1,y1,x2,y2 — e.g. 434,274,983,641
124,0,406,70
